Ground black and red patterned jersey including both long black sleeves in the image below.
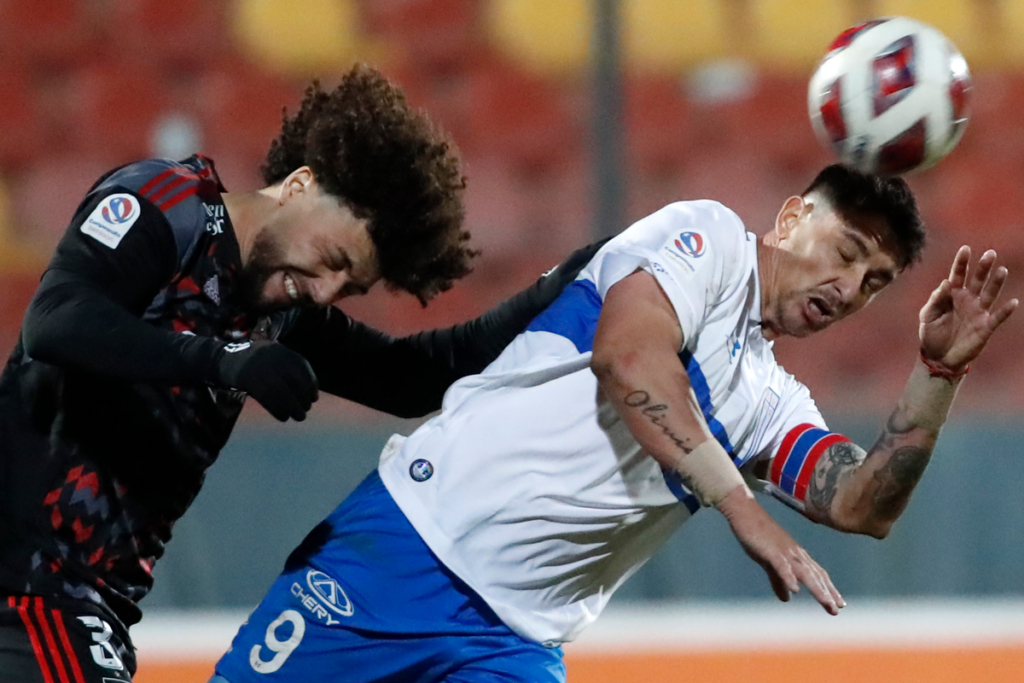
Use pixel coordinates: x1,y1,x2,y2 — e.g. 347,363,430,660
0,156,599,625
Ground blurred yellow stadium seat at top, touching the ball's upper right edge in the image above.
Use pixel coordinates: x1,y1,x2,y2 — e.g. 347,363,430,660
876,0,995,67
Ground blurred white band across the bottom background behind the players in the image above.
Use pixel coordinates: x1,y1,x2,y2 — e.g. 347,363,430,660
131,597,1024,661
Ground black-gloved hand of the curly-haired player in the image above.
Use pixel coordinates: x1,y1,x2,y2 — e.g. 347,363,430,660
211,341,318,422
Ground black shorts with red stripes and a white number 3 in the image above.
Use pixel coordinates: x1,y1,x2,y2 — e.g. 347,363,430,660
0,594,135,683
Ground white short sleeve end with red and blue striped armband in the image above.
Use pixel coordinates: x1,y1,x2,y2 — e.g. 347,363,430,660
757,376,850,512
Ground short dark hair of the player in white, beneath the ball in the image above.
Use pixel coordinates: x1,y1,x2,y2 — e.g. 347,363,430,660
803,164,925,269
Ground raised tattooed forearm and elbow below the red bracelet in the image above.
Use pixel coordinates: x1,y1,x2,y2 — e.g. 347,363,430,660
808,360,959,538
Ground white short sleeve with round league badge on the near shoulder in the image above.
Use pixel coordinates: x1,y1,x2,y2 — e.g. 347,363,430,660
595,201,746,340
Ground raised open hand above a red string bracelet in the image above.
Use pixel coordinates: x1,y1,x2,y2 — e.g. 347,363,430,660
919,246,1018,374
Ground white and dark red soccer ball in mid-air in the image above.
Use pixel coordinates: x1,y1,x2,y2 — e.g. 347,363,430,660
807,16,971,175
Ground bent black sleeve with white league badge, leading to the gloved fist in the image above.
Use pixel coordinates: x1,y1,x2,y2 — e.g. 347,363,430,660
22,187,222,384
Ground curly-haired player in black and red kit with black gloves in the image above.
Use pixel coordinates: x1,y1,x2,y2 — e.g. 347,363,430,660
0,62,594,683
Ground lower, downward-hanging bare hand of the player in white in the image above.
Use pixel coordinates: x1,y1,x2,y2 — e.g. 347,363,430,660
717,486,846,614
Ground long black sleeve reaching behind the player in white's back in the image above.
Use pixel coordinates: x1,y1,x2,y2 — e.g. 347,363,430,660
281,243,603,418
